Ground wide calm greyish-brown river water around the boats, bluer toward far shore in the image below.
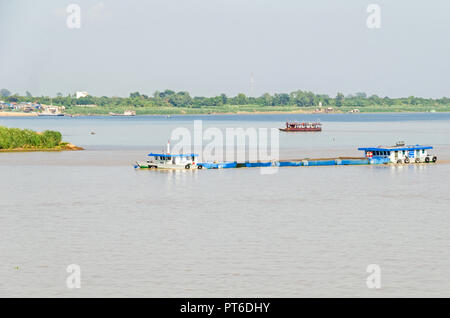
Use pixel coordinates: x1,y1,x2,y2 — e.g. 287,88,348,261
0,113,450,297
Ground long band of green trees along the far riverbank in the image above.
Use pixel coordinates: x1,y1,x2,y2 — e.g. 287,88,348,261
0,89,450,108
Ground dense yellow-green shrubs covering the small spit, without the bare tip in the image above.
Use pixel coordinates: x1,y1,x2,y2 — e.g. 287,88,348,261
0,126,62,149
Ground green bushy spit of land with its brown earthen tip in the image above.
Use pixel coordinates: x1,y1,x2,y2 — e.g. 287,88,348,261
0,126,82,151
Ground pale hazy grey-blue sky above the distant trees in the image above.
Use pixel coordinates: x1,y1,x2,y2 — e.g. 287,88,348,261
0,0,450,97
